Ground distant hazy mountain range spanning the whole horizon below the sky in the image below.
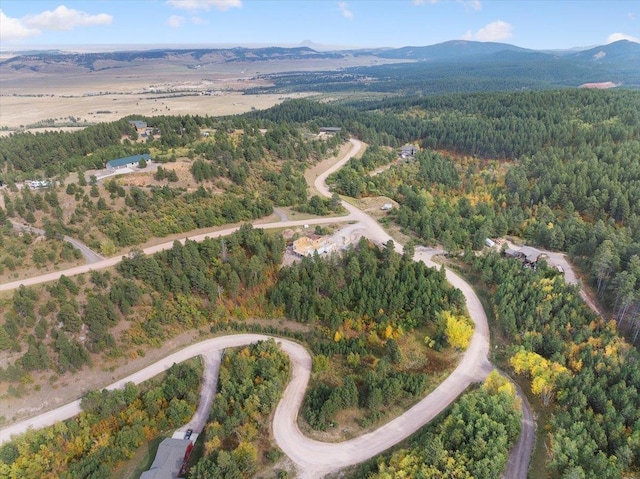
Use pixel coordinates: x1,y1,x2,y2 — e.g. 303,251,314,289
0,40,640,92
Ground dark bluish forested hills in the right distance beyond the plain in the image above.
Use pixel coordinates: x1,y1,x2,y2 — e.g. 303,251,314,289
251,40,640,95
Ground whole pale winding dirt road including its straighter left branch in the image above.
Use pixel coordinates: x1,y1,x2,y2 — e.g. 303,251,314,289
0,140,526,479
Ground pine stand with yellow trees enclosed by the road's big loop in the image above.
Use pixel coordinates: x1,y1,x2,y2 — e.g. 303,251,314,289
269,240,464,430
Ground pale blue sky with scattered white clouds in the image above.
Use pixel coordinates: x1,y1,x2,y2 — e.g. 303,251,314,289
0,0,640,50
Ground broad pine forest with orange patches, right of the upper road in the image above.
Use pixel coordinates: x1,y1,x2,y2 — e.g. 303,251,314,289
253,90,640,335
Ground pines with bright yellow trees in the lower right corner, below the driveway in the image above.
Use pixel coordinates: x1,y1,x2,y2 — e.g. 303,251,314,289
471,254,640,479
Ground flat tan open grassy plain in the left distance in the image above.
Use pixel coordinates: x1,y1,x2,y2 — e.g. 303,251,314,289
0,56,392,130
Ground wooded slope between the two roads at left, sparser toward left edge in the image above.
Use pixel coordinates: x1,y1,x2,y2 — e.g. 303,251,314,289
0,225,284,382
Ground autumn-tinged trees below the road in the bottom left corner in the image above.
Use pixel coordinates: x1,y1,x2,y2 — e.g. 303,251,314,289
0,363,200,479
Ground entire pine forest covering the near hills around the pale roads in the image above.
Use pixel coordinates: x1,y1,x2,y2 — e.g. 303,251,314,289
0,90,640,478
